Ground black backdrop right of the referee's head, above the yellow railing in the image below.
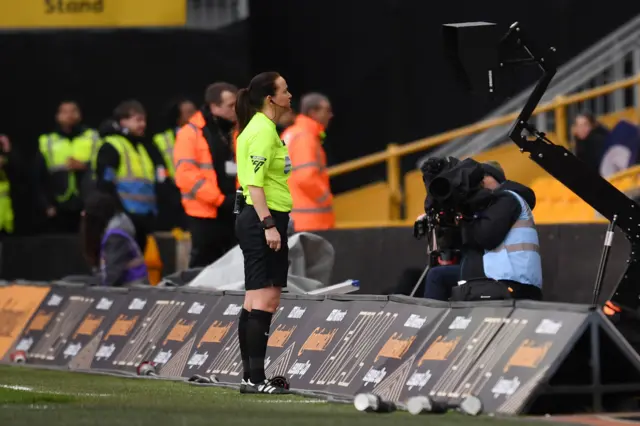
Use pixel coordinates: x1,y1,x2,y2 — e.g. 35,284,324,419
251,0,640,192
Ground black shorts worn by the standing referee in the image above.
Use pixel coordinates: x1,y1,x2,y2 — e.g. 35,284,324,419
236,205,289,290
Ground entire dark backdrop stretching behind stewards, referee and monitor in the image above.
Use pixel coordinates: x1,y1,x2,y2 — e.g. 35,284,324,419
0,0,640,234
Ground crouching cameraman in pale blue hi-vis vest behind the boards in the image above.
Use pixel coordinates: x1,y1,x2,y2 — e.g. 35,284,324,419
452,162,542,301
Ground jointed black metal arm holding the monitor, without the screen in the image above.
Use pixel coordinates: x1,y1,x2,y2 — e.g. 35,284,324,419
502,22,640,314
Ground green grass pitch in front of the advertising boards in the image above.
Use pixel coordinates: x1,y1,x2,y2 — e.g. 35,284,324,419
0,366,564,426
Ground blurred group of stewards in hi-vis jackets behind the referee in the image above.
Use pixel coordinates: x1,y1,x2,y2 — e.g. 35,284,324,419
0,82,335,284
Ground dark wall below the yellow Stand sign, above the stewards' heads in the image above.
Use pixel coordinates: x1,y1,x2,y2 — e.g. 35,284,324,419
0,22,251,154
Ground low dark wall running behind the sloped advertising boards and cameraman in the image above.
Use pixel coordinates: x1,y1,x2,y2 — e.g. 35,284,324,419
0,224,629,303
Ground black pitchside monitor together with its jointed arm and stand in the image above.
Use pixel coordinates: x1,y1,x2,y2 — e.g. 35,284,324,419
444,22,640,351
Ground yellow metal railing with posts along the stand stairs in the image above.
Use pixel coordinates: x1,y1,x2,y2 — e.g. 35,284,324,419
328,75,640,222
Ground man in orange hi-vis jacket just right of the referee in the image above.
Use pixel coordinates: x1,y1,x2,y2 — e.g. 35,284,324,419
282,93,335,232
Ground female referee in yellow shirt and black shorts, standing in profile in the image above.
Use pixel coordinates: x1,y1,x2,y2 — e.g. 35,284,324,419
236,72,292,394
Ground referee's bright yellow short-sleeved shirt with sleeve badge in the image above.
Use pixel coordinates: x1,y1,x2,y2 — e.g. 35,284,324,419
236,112,293,212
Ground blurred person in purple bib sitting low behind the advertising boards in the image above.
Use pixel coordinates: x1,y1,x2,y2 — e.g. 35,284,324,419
82,192,148,287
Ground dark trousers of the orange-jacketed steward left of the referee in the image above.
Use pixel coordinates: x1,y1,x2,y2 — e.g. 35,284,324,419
187,216,237,268
